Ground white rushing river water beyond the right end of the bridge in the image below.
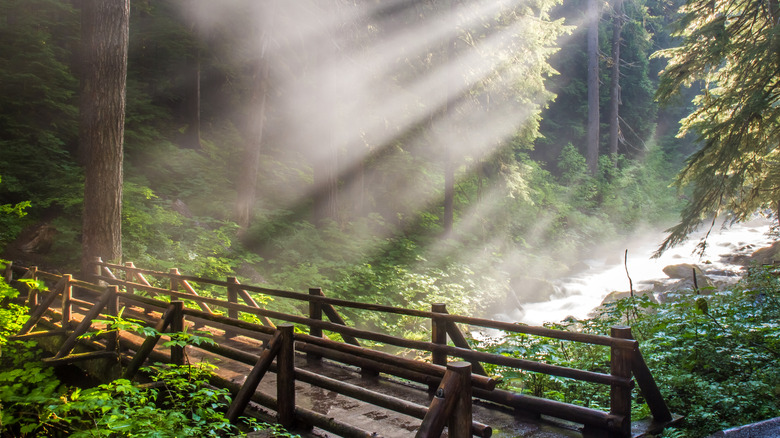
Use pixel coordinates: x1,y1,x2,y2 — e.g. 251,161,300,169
508,218,780,325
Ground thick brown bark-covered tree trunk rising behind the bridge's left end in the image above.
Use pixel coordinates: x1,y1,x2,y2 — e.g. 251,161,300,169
79,0,130,276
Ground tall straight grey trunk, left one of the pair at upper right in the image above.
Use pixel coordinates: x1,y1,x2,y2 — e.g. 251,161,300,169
585,0,601,176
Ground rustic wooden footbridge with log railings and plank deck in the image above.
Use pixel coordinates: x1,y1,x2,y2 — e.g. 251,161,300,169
5,260,673,438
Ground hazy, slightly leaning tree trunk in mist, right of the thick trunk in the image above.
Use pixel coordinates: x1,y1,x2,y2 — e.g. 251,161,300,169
235,60,270,237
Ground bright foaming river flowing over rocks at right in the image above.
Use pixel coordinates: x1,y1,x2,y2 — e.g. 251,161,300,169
499,219,774,325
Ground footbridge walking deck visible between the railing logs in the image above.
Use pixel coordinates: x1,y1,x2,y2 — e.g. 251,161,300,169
41,308,583,438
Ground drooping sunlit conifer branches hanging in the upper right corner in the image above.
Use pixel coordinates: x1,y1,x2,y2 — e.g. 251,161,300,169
658,0,780,253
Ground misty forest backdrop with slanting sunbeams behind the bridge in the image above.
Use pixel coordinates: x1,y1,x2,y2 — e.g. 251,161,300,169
0,0,748,318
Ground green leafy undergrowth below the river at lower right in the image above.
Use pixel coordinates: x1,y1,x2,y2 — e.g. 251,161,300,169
481,268,780,437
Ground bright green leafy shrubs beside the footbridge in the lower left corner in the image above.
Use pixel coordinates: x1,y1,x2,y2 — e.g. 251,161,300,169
0,296,297,438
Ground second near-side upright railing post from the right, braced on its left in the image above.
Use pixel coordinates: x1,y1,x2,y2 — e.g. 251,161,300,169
276,324,295,429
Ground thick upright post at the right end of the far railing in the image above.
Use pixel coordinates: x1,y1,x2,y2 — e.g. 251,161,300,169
609,326,633,438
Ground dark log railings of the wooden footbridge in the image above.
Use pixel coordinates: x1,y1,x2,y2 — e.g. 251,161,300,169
5,260,672,437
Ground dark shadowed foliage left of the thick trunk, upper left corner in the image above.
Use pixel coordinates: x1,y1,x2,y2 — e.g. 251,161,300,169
0,0,79,208
